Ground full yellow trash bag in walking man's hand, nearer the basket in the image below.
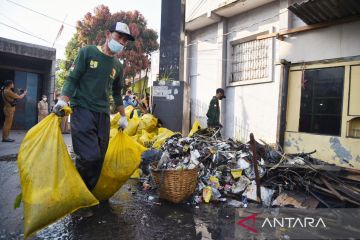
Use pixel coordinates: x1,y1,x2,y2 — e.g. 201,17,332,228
93,131,146,201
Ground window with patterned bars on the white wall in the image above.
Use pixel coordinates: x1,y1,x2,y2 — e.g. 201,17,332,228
231,39,271,82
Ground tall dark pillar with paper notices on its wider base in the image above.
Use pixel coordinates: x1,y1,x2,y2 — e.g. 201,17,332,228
152,0,190,135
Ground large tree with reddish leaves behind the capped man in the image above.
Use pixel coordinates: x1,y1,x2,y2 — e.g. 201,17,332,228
58,5,159,92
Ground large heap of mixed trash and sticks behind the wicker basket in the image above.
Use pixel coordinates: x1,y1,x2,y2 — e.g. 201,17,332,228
140,128,360,208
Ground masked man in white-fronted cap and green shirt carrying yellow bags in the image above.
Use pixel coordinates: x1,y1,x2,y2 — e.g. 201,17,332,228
53,22,134,191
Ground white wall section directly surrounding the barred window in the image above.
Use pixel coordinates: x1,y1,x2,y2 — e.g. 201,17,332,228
224,2,280,143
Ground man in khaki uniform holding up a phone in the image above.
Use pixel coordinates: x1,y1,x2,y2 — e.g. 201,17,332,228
2,80,27,142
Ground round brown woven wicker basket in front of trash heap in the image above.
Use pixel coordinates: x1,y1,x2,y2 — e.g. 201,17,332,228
151,162,199,203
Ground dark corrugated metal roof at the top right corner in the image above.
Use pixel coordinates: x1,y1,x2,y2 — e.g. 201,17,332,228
288,0,360,25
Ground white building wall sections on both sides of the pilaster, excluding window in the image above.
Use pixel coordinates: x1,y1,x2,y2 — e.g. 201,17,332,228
187,1,280,143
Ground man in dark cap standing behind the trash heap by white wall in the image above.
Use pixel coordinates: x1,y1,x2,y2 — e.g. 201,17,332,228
206,88,226,128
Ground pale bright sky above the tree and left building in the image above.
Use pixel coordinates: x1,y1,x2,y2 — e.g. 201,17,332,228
0,0,161,58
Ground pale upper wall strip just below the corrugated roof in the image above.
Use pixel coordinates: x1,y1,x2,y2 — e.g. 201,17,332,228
280,17,360,63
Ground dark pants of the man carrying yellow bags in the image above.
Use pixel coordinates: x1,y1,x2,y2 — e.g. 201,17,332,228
71,107,110,191
